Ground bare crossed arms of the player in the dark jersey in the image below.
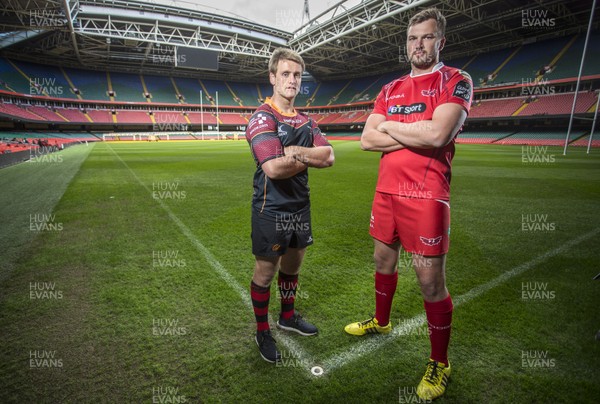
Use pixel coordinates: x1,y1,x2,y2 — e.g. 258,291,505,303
261,146,335,180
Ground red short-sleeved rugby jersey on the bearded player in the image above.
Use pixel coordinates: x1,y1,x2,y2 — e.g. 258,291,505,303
372,62,473,200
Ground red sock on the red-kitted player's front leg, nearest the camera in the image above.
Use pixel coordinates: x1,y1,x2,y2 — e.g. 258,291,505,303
423,295,454,365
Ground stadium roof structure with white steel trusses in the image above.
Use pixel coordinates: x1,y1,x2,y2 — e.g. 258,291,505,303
0,0,600,82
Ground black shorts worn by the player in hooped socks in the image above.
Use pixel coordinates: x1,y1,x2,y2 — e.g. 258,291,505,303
251,209,313,257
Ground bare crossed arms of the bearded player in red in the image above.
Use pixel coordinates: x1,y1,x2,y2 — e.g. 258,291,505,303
360,103,467,153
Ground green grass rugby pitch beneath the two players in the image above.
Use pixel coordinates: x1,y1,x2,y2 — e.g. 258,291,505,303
0,141,600,403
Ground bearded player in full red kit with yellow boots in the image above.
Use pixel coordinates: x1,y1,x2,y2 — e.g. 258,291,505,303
345,8,473,400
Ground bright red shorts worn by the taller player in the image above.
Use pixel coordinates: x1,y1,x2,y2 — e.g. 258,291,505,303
369,192,450,256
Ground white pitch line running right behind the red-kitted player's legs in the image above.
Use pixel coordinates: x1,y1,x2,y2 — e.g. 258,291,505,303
314,228,600,376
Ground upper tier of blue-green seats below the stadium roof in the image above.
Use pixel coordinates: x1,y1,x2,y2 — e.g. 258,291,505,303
0,32,600,107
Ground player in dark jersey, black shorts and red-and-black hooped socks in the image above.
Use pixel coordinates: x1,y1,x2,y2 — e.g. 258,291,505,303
246,48,335,362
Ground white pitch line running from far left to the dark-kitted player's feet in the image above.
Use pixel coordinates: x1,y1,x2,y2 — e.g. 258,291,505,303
106,144,313,363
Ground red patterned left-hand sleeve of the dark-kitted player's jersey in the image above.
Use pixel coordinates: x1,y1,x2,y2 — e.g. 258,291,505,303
246,111,285,166
